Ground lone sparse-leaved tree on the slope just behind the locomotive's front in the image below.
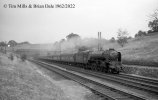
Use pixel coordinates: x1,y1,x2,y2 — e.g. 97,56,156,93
117,29,128,47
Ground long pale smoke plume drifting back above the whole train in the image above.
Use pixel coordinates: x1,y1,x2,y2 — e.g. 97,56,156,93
16,34,118,55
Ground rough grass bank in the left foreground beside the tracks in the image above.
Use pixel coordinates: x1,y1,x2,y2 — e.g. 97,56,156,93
0,54,69,100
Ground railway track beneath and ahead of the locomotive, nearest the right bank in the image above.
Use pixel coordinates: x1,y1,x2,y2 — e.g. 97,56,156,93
39,58,158,94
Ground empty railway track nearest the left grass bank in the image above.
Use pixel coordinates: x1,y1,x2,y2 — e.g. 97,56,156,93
31,60,156,100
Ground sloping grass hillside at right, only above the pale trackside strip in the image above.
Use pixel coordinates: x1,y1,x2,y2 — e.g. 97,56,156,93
118,35,158,67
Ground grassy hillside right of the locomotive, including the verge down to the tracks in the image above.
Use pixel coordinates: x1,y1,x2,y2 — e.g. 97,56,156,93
118,33,158,78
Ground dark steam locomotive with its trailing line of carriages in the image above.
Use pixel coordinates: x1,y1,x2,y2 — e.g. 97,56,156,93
40,49,122,73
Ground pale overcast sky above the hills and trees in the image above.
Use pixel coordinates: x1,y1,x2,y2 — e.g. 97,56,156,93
0,0,158,43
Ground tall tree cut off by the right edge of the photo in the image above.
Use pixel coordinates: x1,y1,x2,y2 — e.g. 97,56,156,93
148,9,158,32
